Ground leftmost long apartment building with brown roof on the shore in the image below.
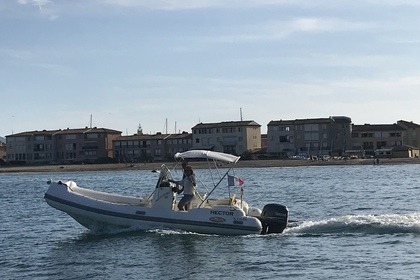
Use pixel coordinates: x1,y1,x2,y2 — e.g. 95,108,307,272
6,127,121,164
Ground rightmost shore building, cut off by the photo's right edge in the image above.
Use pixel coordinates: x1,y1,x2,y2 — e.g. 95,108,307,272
352,120,420,157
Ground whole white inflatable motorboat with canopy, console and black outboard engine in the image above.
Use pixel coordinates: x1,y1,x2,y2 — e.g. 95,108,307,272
45,150,288,235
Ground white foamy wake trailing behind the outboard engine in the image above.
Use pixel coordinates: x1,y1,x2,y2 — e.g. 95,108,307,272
284,212,420,235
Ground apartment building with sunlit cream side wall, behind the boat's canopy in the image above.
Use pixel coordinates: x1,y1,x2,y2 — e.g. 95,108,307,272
192,121,261,155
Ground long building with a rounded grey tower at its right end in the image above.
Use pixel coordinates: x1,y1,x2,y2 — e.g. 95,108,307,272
267,116,352,157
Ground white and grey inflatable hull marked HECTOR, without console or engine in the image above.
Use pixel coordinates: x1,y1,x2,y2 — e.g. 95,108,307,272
45,182,262,235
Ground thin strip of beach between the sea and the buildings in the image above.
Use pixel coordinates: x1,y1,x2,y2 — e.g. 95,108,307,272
0,158,420,174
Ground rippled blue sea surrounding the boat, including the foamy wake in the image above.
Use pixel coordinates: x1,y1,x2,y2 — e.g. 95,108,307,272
0,165,420,279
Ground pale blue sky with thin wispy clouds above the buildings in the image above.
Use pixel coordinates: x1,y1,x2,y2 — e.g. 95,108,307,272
0,0,420,136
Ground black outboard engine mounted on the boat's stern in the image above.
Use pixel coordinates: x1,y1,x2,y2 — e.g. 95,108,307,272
259,203,289,234
